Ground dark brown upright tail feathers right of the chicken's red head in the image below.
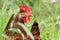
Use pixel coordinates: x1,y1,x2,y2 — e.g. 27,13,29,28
31,21,40,40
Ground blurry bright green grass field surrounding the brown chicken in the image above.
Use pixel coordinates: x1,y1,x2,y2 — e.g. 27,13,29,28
0,0,60,40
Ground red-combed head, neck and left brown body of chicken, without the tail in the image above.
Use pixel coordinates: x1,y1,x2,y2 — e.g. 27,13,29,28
4,5,32,40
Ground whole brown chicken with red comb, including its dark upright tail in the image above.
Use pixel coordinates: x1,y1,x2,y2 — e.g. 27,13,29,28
4,5,40,40
